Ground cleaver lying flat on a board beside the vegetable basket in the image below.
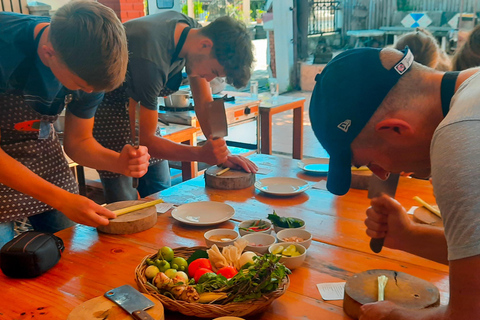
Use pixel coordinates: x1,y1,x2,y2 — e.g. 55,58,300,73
104,284,155,320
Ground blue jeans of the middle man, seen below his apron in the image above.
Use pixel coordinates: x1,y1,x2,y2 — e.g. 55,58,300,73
100,160,172,203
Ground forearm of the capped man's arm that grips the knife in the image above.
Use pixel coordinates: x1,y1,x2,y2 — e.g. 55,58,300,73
397,223,448,265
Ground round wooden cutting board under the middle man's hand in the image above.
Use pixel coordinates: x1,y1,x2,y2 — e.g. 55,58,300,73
205,166,255,190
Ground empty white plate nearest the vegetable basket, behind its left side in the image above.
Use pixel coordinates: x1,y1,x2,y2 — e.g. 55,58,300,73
172,201,235,226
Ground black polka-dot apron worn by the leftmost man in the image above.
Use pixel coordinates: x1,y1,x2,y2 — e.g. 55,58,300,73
0,29,78,223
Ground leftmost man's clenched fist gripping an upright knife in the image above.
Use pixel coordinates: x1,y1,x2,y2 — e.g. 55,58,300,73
118,144,150,178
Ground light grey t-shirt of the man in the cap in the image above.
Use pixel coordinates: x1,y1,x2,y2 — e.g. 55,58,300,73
430,72,480,260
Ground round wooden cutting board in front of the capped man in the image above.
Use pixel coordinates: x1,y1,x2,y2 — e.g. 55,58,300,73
343,269,440,319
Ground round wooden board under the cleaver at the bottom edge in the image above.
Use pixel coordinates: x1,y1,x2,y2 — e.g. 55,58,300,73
67,294,165,320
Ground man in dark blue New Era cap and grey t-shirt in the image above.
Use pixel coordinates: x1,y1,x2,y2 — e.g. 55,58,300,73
310,48,480,320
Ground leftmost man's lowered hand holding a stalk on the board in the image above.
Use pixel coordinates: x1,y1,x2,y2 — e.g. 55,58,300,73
57,193,116,227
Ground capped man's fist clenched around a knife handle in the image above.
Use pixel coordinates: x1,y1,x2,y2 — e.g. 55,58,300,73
365,195,412,249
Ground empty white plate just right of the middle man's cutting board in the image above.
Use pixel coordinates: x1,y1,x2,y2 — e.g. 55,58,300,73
255,178,311,196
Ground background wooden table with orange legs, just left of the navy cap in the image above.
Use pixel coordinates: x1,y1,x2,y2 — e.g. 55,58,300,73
260,96,305,159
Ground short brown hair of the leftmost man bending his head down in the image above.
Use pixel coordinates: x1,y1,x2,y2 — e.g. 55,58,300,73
49,0,128,91
